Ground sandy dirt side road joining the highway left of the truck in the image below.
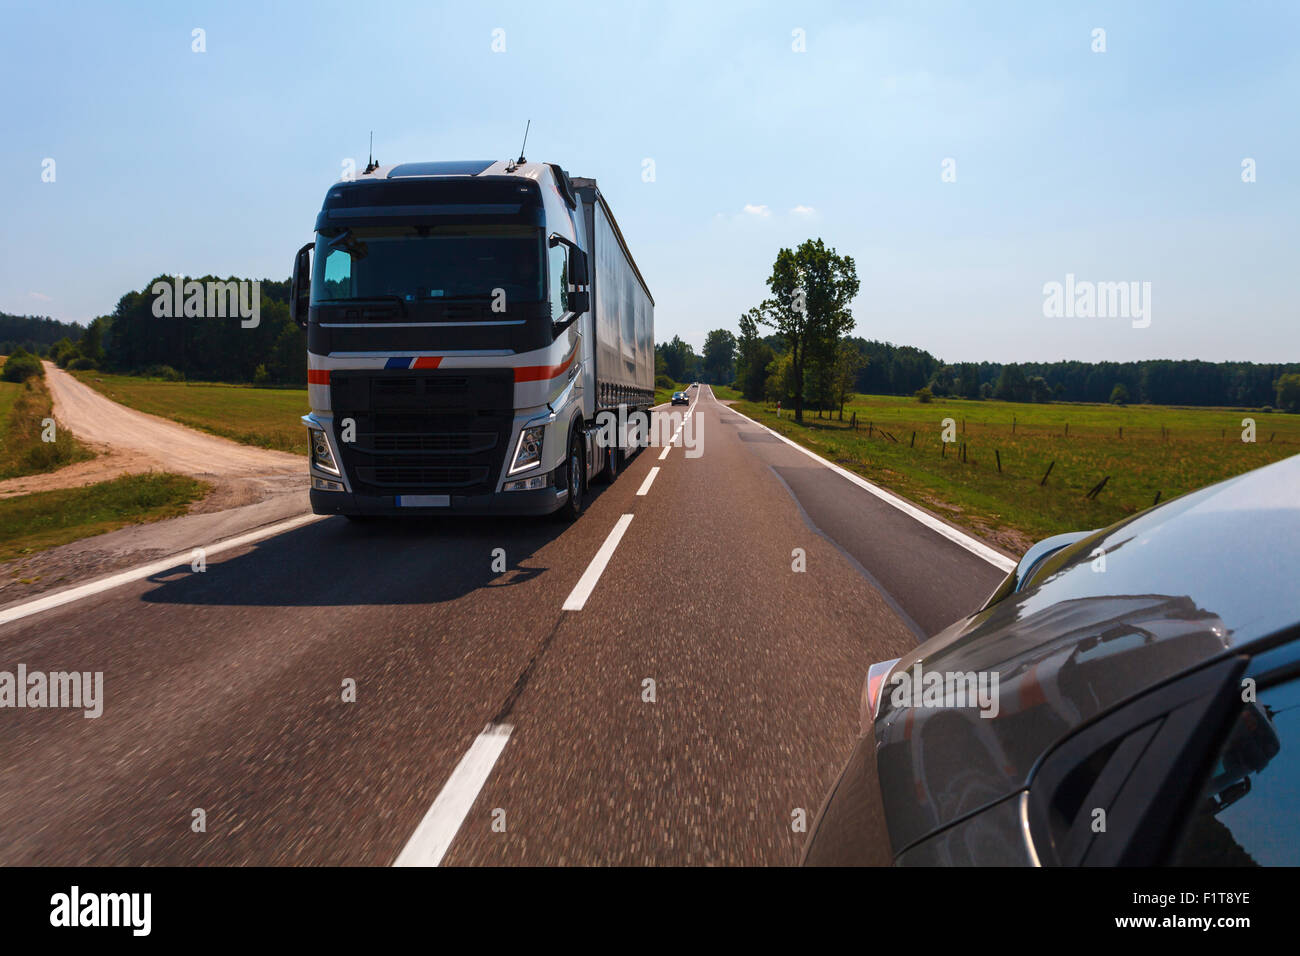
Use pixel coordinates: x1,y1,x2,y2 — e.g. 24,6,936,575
0,362,307,512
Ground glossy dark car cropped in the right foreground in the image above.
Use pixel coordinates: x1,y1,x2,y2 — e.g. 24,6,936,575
803,455,1300,866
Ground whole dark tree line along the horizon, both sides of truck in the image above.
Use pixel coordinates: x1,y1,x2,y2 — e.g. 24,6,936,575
0,265,1300,418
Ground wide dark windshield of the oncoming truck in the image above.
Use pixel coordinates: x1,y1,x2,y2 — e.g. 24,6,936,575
312,225,546,304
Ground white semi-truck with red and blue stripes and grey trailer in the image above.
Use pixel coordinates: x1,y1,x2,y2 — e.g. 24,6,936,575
290,156,654,520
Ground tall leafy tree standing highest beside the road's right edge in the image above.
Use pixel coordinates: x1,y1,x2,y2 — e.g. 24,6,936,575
761,239,858,423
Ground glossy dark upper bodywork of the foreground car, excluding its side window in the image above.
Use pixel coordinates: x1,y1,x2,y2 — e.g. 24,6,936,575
875,455,1300,852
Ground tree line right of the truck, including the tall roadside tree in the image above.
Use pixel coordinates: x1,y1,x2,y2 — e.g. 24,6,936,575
657,239,1300,420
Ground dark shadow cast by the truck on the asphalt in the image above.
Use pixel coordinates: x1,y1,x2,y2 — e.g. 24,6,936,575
142,516,571,607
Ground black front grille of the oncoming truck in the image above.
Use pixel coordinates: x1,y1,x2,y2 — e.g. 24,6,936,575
330,368,515,494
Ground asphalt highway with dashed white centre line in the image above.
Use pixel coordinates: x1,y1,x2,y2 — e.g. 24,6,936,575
0,386,1002,865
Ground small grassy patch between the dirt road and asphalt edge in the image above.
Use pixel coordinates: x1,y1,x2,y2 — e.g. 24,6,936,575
0,472,208,561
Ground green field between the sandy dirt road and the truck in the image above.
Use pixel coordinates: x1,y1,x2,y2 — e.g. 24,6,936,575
75,372,309,455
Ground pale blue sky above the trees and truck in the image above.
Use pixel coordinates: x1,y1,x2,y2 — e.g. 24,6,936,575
0,0,1300,362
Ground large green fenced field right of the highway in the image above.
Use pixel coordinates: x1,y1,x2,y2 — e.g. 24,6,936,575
715,389,1300,551
